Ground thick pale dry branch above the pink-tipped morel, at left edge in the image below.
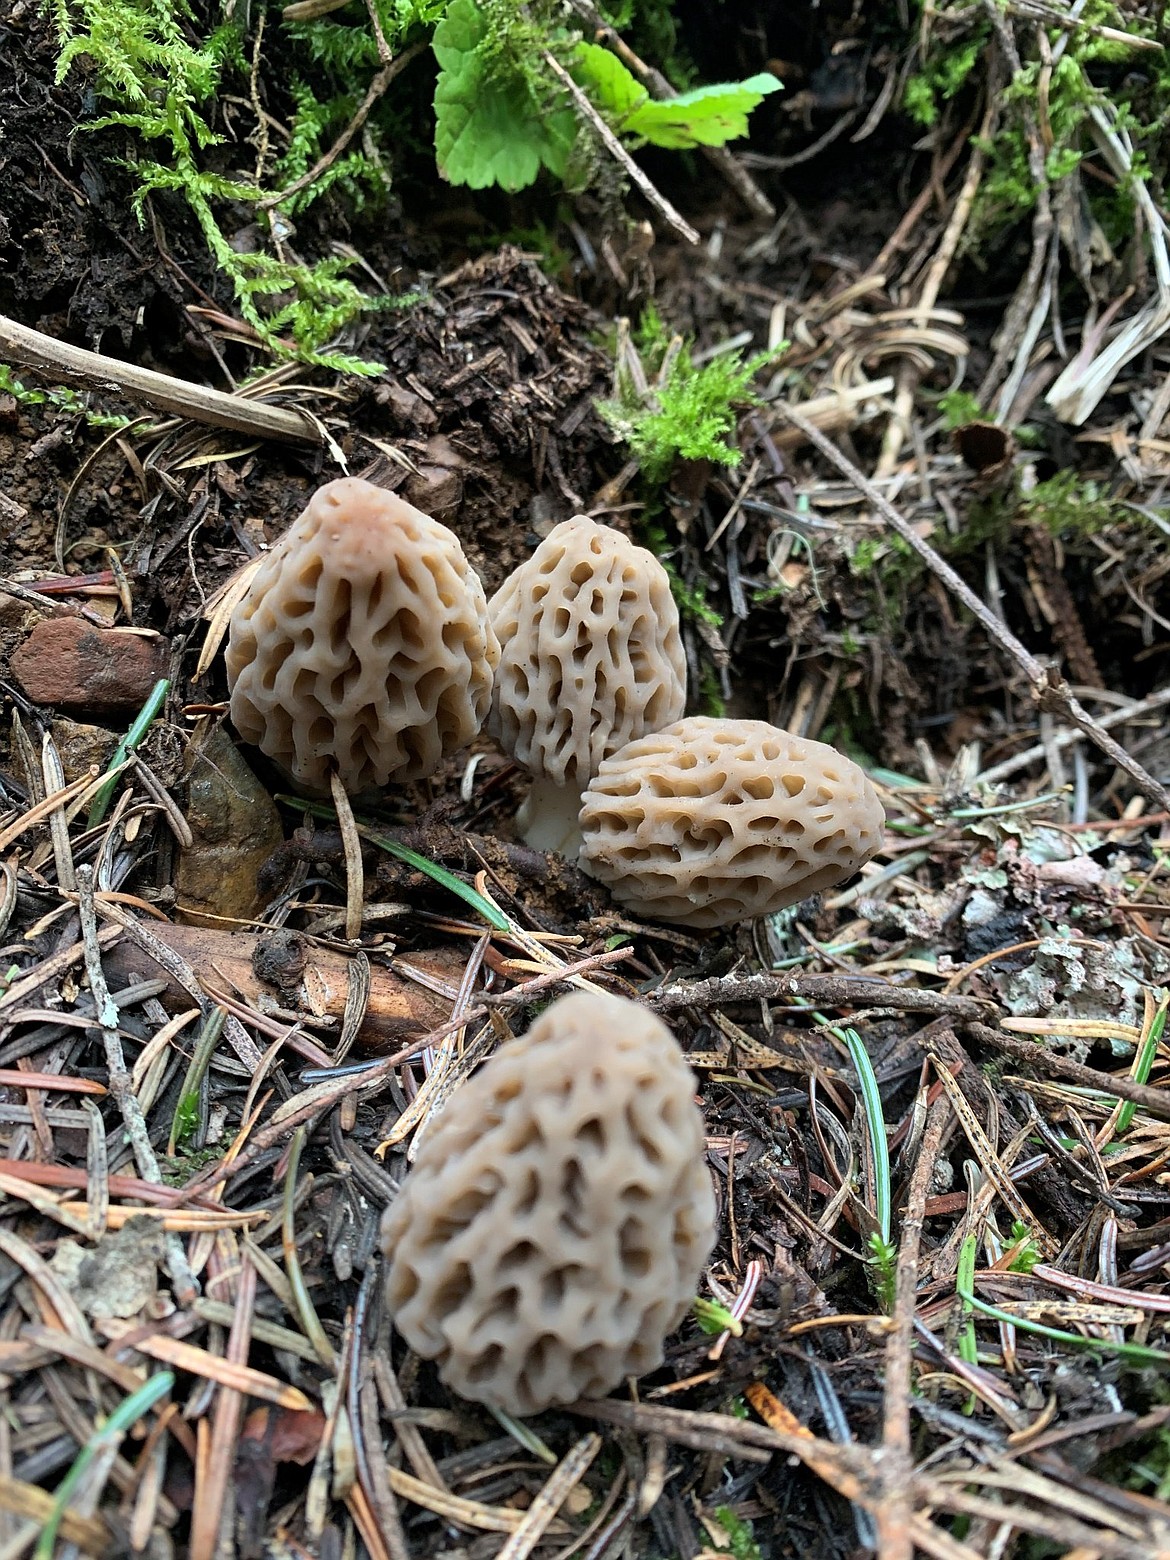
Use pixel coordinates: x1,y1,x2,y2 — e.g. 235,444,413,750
0,315,323,445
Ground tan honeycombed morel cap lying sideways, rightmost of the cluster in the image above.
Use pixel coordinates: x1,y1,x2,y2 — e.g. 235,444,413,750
580,716,885,927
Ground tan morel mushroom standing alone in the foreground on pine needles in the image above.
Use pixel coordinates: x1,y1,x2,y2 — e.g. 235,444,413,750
382,991,714,1413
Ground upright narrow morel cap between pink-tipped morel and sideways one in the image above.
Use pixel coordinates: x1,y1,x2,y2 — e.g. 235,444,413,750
488,515,686,789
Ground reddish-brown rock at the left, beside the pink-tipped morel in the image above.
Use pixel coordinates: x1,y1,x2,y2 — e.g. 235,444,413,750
12,618,170,716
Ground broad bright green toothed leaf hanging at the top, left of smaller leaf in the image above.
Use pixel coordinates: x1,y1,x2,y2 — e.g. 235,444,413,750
431,0,577,190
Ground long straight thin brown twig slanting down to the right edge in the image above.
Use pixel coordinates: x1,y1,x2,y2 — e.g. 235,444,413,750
778,402,1170,810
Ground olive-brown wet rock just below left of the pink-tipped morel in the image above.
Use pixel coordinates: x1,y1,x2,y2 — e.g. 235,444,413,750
175,722,284,927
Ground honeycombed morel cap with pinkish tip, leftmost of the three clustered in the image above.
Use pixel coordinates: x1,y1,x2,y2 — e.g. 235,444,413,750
226,477,499,796
